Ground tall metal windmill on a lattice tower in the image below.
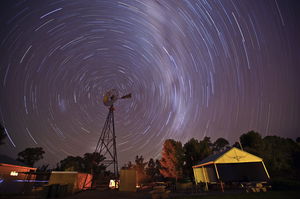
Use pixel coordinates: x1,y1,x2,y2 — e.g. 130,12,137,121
95,89,131,179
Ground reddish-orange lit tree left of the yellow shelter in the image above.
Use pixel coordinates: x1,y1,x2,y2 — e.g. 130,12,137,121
160,139,184,180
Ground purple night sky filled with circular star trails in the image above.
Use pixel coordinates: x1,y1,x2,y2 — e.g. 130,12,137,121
0,0,300,166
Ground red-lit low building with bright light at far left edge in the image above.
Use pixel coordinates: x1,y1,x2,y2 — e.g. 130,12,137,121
0,155,36,194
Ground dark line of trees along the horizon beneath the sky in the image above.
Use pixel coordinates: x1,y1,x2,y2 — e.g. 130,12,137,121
0,125,300,181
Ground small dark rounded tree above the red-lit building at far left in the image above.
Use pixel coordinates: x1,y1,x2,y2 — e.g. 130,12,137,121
17,147,45,166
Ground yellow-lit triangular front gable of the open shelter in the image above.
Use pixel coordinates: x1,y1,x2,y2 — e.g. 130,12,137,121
215,148,262,164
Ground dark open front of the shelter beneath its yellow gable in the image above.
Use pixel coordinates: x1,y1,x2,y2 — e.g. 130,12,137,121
216,162,268,182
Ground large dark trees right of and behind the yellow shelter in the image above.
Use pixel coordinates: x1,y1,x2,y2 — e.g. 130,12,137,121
240,131,300,179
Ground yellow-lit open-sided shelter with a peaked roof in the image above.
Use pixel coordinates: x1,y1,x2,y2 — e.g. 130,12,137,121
193,147,270,190
